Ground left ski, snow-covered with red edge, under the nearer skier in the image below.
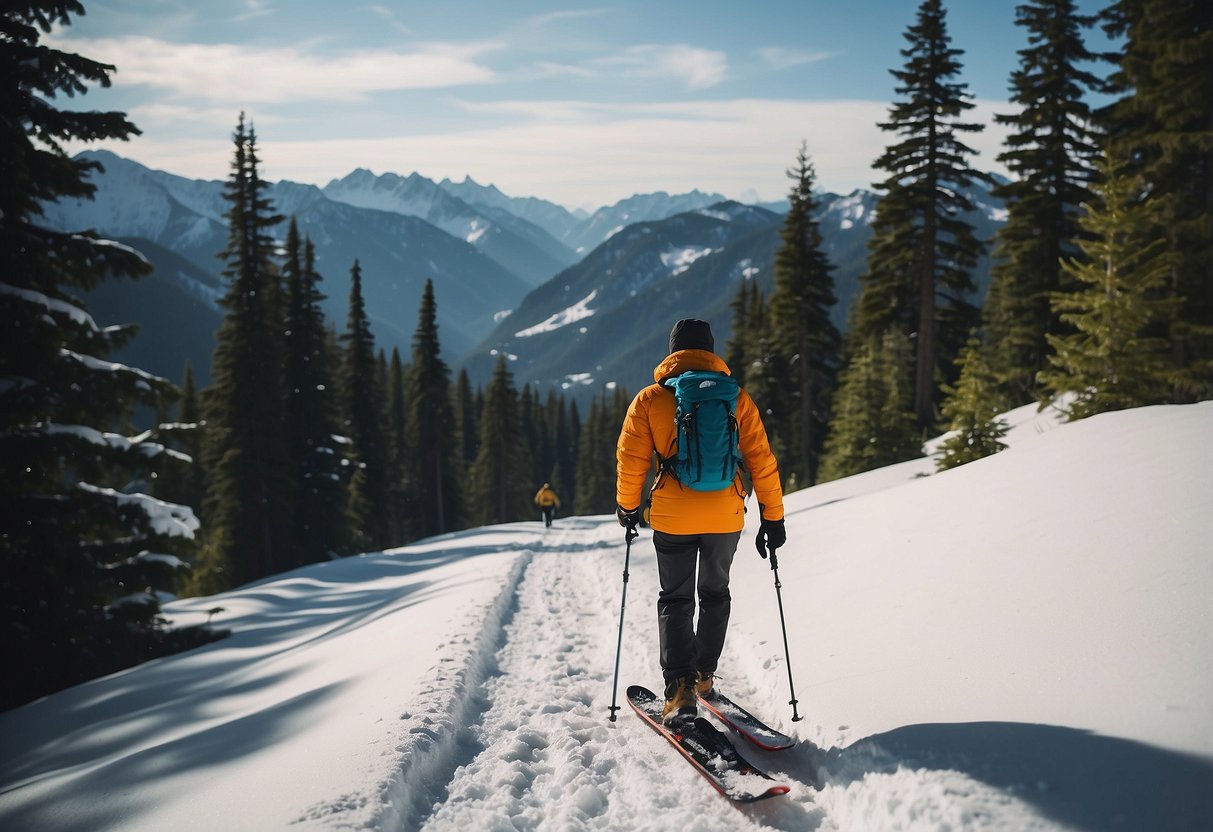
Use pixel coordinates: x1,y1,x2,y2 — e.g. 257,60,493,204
627,685,791,803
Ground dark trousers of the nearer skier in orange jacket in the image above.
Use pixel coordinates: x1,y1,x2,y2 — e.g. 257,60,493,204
653,531,741,684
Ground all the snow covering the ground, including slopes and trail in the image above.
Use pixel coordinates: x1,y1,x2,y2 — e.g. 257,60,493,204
0,403,1213,831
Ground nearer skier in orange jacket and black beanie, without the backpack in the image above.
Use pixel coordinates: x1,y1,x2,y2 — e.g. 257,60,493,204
615,319,786,722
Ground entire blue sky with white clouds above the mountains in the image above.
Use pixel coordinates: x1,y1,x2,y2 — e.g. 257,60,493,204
51,0,1106,207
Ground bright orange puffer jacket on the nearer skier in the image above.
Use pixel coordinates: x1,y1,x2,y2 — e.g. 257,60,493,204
615,349,784,535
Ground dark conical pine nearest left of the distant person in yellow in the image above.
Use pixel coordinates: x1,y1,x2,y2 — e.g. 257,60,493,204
471,355,534,525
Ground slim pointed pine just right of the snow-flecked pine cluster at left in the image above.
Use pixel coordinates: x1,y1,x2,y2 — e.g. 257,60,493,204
341,260,392,552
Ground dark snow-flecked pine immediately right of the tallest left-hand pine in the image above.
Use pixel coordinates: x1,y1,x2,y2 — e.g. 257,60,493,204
283,220,346,566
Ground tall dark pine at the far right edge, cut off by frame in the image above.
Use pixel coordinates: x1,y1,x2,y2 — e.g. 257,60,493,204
1105,0,1213,401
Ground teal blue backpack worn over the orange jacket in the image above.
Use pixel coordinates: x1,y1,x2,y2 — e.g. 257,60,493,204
661,370,741,491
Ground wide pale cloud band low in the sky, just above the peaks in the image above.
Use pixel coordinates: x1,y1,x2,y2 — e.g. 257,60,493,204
78,98,1008,212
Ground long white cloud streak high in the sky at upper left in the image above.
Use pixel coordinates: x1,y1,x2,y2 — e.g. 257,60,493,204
50,36,496,104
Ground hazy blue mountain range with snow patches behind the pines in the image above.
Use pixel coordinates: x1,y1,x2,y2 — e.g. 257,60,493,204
44,152,1003,398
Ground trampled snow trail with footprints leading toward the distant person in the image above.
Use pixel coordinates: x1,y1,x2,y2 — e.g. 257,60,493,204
402,518,821,830
